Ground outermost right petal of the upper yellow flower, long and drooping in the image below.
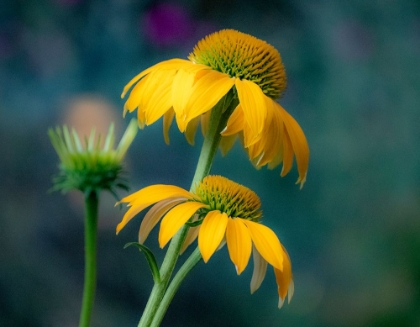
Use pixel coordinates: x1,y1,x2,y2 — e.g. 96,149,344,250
278,104,309,188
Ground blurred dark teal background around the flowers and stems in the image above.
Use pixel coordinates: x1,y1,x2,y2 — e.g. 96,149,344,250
0,0,420,327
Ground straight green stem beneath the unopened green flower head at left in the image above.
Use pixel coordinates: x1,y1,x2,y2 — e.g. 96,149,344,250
79,191,99,327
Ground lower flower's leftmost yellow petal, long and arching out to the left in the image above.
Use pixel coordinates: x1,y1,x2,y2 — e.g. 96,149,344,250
117,185,193,234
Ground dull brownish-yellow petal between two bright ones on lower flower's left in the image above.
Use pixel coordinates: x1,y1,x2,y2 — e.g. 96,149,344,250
139,198,185,244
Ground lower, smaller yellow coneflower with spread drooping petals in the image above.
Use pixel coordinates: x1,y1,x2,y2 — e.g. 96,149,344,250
117,176,293,307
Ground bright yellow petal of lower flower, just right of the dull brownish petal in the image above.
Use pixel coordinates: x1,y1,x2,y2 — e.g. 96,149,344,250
159,202,206,248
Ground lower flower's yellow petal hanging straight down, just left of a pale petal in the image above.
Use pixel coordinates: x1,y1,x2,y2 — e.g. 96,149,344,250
226,218,252,275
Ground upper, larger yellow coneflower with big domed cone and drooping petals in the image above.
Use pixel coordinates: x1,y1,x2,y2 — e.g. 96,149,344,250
122,30,309,187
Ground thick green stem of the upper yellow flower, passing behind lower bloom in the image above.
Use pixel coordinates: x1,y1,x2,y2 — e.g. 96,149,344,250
138,91,237,327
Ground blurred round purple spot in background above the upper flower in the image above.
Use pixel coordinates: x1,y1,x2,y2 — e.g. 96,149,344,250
143,3,194,46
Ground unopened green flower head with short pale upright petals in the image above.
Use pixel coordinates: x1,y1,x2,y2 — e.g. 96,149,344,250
48,120,138,194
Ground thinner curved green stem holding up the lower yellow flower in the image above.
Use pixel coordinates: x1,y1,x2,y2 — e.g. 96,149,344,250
150,247,201,327
